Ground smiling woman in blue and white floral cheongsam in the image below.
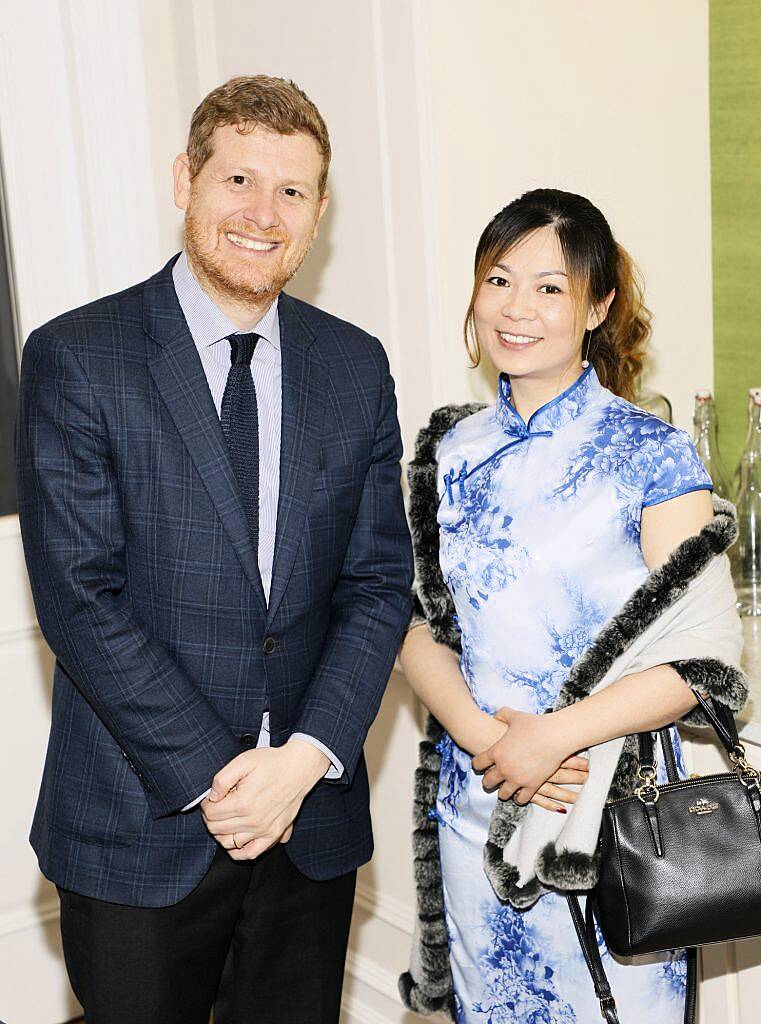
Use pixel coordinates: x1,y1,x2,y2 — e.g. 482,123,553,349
401,189,745,1024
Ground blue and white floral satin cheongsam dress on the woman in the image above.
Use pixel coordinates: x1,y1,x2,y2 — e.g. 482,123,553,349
436,368,711,1024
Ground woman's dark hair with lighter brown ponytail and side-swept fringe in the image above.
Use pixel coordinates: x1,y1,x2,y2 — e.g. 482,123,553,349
465,188,651,401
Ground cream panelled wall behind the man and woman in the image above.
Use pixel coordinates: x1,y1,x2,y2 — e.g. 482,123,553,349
0,0,759,1024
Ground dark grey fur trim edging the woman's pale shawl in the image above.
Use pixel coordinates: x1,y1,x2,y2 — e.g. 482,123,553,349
399,403,748,1019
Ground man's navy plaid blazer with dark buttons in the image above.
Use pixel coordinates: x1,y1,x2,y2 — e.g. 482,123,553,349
16,257,412,906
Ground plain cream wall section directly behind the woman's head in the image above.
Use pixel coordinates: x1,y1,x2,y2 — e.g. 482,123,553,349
425,0,713,427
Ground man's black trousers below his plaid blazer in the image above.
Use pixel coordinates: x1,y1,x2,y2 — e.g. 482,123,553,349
58,846,356,1024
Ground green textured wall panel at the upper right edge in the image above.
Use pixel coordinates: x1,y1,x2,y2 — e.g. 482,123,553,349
710,0,761,472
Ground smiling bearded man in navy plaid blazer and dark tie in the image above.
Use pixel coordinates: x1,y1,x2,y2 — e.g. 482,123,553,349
16,76,411,1024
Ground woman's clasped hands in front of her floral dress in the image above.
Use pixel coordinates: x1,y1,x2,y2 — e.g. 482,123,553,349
472,708,589,813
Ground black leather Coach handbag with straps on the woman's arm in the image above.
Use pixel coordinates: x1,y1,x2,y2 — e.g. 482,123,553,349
568,692,761,1024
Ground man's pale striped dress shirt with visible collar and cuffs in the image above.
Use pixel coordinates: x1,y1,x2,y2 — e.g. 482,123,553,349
172,253,343,798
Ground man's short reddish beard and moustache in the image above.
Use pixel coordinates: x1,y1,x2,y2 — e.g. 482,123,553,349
185,209,312,305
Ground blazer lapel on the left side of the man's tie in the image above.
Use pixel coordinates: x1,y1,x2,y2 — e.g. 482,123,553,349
143,259,266,608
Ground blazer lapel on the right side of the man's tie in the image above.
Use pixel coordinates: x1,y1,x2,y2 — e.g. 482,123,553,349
267,295,326,623
